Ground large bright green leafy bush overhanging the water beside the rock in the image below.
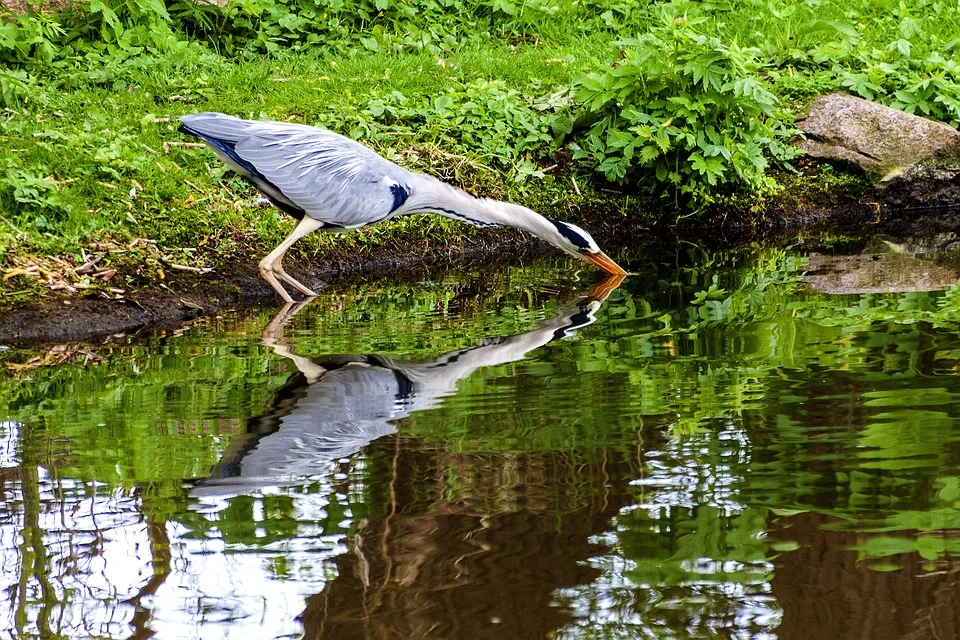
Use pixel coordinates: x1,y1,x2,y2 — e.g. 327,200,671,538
574,5,800,207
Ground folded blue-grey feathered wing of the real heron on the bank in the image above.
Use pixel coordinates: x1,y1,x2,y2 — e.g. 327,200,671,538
234,122,410,229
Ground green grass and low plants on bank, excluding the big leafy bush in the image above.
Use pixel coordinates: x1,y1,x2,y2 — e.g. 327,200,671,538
0,0,960,304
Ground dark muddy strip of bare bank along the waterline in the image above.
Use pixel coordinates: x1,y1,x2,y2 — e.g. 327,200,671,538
0,196,944,345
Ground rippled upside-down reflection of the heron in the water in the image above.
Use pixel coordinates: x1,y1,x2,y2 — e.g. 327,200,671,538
191,276,624,496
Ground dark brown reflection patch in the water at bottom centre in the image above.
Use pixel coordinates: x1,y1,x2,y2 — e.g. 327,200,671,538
302,438,632,638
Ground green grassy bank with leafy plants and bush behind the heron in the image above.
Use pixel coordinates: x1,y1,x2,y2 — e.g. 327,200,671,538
0,0,960,302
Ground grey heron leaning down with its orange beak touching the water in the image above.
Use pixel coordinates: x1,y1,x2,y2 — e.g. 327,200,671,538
180,113,627,302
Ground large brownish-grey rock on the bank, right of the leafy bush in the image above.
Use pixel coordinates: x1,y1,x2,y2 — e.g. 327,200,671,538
797,93,960,205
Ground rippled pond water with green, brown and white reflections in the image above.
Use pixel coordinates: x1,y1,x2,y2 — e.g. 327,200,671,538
0,231,960,639
